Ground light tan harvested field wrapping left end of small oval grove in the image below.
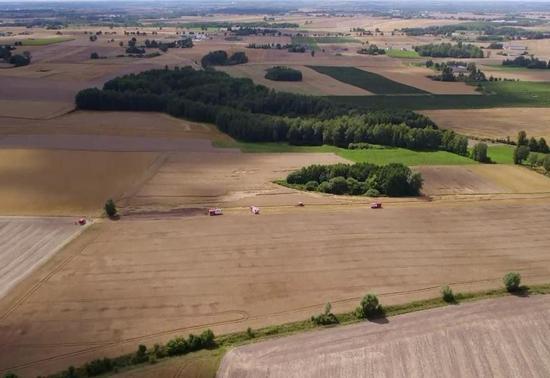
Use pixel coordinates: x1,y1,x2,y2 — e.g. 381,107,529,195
126,150,347,212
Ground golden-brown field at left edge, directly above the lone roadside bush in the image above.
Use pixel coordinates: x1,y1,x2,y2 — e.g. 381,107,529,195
0,149,158,215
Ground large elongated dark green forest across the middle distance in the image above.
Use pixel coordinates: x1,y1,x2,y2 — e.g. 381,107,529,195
76,67,467,155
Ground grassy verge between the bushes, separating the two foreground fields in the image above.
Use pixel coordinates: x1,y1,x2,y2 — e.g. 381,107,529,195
72,284,550,377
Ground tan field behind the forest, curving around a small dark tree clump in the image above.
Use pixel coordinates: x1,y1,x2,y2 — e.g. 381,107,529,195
220,64,372,96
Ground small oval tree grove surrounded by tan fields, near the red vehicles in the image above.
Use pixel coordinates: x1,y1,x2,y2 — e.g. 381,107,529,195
286,163,423,197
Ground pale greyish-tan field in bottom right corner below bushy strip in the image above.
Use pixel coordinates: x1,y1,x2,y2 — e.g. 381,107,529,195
218,295,550,378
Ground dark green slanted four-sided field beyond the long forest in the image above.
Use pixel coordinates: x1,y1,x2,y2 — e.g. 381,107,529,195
308,66,428,97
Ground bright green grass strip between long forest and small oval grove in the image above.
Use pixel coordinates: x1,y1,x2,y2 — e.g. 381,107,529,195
213,142,477,165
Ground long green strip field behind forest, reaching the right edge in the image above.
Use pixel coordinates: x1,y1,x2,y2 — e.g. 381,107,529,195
328,81,550,110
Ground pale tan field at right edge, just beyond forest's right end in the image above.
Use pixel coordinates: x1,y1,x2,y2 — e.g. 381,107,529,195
421,108,550,140
